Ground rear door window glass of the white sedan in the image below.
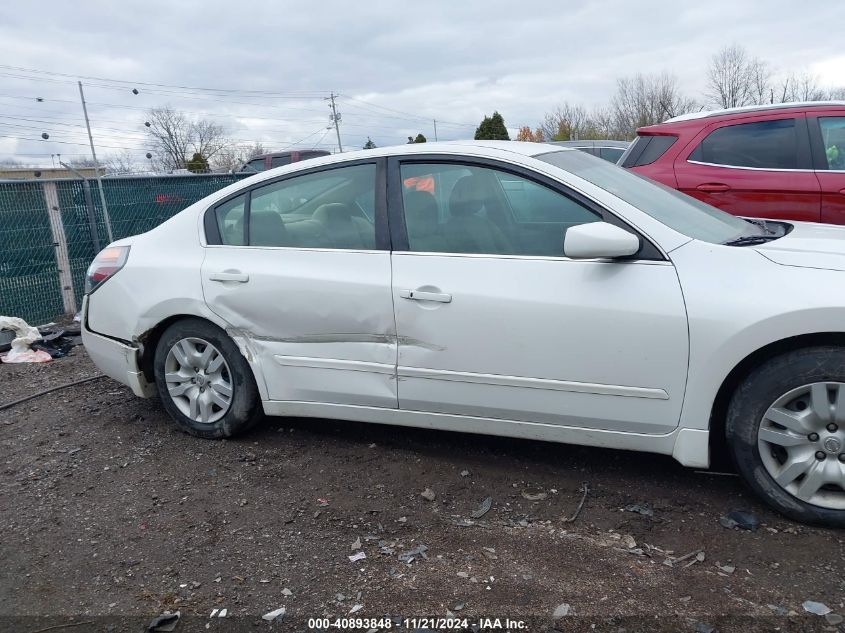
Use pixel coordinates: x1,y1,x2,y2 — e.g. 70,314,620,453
214,164,376,249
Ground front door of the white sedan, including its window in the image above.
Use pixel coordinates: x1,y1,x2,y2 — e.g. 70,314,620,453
390,159,688,433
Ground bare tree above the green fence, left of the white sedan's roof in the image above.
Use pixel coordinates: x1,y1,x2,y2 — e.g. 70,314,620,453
146,106,231,170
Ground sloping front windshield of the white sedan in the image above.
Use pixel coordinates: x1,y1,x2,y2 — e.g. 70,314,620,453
534,151,762,244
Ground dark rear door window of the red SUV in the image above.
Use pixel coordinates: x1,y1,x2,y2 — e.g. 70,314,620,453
688,119,798,169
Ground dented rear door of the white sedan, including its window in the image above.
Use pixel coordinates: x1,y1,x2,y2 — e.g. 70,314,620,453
202,162,397,408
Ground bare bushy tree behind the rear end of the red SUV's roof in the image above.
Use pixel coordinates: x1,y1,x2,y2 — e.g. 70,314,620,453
610,73,697,138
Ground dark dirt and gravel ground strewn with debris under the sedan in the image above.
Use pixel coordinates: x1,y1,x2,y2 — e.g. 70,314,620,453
0,348,845,633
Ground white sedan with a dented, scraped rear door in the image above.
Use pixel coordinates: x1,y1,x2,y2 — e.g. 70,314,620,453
83,142,845,527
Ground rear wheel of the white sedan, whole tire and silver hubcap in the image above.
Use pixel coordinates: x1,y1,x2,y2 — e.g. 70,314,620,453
153,319,261,439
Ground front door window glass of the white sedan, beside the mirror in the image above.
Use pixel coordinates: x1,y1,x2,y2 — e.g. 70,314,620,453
401,163,601,257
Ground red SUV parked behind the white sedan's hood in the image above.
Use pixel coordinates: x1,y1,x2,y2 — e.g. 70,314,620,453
619,102,845,224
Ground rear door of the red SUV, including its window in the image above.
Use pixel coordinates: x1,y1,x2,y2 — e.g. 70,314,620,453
675,112,821,222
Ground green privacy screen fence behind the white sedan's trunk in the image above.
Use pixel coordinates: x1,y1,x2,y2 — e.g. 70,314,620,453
0,174,243,324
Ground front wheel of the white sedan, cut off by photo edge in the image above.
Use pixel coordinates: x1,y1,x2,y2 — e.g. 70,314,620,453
725,346,845,528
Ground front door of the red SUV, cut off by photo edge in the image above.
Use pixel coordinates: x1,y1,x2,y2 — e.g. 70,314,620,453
807,110,845,224
